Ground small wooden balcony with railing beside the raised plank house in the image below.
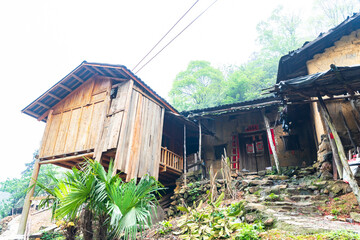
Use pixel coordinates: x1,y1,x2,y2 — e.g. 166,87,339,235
159,147,184,176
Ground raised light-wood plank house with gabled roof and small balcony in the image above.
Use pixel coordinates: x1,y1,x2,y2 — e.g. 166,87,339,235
22,62,198,183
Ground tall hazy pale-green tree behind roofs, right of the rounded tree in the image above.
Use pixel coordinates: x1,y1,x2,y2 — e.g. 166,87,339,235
223,7,302,103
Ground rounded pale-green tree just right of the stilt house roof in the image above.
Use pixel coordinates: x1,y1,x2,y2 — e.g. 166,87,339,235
169,61,224,111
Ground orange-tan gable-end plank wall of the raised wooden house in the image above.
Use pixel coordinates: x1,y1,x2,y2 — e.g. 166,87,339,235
39,77,111,158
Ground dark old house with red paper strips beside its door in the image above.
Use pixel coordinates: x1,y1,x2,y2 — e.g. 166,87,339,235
184,97,316,172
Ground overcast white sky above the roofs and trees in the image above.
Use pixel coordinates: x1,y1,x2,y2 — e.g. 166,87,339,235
0,0,312,181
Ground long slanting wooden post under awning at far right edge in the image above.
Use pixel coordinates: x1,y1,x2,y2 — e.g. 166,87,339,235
317,93,360,203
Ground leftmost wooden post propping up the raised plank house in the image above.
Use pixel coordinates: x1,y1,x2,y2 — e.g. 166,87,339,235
18,159,40,235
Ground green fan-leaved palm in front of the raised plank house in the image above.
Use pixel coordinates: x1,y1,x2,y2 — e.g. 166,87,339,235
38,159,163,239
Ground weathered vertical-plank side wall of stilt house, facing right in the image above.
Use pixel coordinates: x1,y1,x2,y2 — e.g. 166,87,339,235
110,88,165,180
